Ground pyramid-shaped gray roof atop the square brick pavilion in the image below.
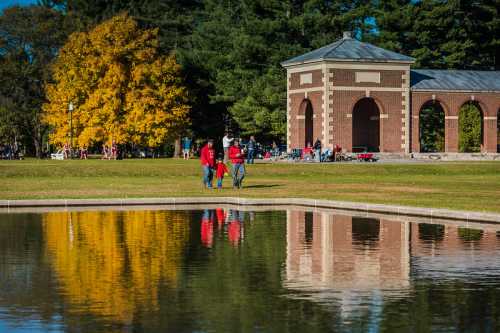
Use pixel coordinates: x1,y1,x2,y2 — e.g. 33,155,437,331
281,36,415,67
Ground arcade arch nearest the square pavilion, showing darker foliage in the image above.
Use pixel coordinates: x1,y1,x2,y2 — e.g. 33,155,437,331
418,101,445,153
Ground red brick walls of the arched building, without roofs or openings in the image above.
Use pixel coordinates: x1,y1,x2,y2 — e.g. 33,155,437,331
288,64,500,153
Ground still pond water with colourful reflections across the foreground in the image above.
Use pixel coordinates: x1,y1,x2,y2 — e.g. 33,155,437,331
0,208,500,332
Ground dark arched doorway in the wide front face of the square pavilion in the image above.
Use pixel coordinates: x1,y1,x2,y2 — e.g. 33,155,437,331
352,98,380,152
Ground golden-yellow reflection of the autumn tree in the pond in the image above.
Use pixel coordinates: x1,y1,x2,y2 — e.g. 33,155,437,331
43,211,189,322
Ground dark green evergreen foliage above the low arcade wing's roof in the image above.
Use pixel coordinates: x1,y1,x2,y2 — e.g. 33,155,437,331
376,0,500,70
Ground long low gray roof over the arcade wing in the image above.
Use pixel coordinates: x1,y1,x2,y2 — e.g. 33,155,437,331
410,69,500,91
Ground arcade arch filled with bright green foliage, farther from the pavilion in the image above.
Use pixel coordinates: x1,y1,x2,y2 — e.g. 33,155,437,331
458,101,483,153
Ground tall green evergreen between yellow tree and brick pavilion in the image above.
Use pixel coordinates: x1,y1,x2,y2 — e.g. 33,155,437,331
183,0,368,140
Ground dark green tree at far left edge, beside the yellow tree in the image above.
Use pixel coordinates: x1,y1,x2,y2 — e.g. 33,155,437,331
0,6,72,157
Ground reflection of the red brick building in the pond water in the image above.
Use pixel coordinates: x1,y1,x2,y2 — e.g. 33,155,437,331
284,210,500,292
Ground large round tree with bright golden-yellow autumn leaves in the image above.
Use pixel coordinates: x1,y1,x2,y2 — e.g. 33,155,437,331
44,14,189,147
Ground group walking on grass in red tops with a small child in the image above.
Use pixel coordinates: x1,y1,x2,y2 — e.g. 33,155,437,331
200,134,248,189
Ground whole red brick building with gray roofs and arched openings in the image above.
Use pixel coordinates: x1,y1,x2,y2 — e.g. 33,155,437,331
282,33,500,154
